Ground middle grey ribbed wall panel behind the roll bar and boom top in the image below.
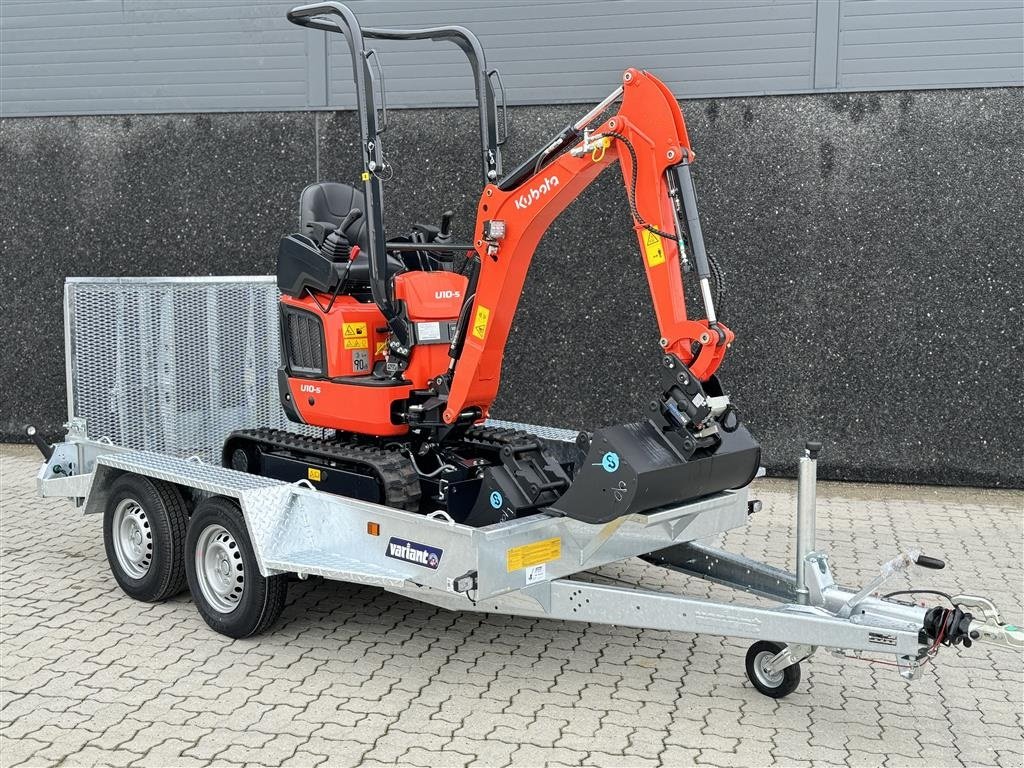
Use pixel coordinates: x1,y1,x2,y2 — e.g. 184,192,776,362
329,0,815,106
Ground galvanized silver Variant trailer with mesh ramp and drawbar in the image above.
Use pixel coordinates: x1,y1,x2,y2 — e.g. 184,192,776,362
38,278,1024,697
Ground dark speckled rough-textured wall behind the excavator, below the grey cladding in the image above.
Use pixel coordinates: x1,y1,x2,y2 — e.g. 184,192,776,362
0,89,1024,486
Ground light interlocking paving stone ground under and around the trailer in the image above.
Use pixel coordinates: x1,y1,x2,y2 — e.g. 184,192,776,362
0,446,1024,768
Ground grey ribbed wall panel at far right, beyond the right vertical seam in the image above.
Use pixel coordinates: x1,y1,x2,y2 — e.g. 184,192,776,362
839,0,1024,90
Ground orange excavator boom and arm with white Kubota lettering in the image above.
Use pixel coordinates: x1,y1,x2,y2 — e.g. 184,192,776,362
443,69,734,427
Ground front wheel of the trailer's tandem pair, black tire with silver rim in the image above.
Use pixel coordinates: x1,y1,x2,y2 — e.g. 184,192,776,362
185,496,288,638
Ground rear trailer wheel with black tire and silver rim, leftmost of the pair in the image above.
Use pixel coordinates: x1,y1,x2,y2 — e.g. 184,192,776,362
103,473,188,603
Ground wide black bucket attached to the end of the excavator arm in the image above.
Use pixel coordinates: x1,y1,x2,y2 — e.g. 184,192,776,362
551,421,761,523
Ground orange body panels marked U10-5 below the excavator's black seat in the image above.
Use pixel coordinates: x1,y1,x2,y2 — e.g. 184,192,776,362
281,271,468,436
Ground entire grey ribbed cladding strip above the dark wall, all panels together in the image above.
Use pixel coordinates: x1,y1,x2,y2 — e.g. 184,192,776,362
0,0,1024,117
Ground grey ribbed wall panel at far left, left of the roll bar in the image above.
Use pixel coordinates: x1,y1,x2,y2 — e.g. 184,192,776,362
0,0,307,116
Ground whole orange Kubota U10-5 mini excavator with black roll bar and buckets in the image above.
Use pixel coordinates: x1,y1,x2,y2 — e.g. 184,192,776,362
223,2,760,526
